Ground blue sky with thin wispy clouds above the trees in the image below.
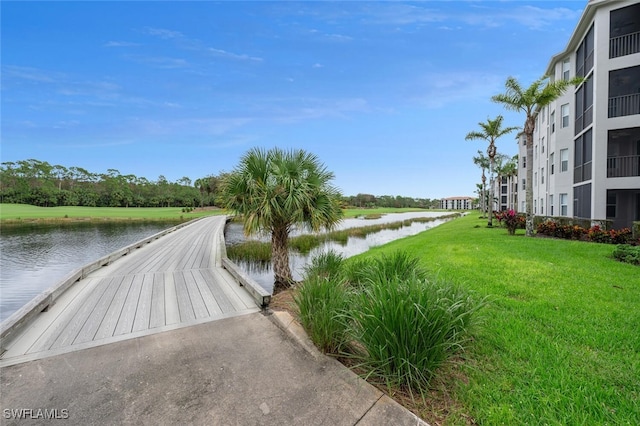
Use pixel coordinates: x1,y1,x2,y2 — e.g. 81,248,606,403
0,0,587,198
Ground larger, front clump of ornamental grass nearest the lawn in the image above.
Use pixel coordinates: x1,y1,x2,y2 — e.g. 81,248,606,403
351,274,481,395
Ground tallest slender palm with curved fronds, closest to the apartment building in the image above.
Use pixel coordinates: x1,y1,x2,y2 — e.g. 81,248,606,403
491,76,585,237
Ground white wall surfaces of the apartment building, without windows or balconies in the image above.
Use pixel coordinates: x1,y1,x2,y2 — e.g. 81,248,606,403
518,0,640,226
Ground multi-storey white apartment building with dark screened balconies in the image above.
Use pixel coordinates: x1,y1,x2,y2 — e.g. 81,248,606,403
517,0,640,229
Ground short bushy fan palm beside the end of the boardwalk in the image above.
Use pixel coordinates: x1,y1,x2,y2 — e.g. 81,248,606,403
221,148,342,294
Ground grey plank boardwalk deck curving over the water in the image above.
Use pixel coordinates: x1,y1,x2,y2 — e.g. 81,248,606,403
0,216,260,366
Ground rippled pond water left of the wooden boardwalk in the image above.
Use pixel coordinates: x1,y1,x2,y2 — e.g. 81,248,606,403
0,221,177,321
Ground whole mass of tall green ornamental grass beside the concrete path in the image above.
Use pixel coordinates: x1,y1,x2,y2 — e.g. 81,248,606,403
294,252,484,395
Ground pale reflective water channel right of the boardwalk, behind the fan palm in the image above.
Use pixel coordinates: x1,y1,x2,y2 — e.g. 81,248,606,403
225,212,450,292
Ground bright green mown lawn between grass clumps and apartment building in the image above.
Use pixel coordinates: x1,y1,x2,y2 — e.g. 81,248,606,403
352,213,640,425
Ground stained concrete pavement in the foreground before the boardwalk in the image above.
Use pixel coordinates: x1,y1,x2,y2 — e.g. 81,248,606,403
0,313,426,426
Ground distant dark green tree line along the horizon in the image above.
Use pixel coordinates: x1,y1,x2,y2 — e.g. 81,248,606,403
0,159,439,208
